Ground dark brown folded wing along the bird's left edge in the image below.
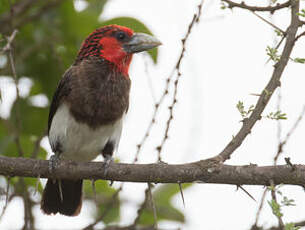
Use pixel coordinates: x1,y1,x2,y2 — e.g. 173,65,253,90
48,67,74,133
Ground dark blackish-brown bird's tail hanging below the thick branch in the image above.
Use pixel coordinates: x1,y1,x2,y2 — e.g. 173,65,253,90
41,179,83,216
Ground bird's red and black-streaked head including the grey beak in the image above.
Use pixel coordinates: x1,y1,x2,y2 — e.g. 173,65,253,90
77,25,161,76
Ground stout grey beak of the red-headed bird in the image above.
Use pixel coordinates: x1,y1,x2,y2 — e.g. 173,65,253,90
123,33,162,53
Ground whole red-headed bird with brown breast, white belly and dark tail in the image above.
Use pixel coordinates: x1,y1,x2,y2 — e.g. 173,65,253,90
41,25,161,216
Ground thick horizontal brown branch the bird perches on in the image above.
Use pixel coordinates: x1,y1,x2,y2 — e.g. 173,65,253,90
0,156,305,185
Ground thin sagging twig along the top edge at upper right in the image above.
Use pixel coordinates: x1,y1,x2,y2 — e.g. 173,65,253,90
222,0,291,14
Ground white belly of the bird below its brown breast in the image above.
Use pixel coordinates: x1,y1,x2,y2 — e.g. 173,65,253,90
49,104,122,161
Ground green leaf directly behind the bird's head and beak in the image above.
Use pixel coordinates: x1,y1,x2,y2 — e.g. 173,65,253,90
101,17,158,63
